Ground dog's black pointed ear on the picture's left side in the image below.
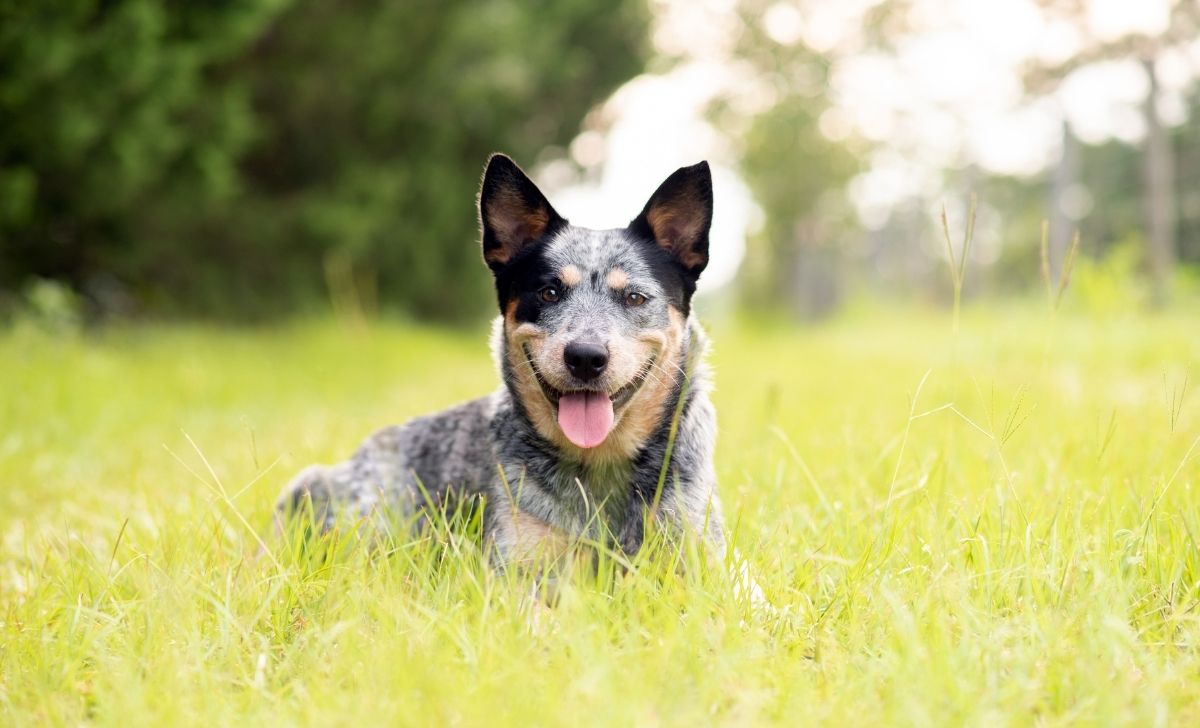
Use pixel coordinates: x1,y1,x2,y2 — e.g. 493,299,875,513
479,154,566,272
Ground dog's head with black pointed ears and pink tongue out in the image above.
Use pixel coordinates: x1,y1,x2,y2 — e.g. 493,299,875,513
479,155,713,457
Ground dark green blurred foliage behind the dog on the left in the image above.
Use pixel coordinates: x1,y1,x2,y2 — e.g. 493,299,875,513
0,0,646,319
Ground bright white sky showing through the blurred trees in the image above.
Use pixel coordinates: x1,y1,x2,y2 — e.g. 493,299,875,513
538,0,1200,290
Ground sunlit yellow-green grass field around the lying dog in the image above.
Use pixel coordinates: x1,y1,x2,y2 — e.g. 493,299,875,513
0,308,1200,726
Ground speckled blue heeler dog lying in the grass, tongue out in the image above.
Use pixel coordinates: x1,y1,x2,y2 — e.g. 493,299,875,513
278,155,725,566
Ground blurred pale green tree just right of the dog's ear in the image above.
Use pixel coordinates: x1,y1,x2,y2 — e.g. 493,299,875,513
716,0,863,318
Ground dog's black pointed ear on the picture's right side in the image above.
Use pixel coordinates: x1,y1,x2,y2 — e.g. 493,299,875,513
629,162,713,277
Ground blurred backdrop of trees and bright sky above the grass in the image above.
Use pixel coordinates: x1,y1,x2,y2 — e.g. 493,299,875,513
0,0,1200,323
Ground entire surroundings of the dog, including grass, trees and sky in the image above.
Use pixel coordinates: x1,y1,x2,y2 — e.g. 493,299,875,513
0,5,1200,728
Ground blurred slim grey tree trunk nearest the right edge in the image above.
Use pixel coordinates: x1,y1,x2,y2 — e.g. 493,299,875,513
1142,58,1175,306
